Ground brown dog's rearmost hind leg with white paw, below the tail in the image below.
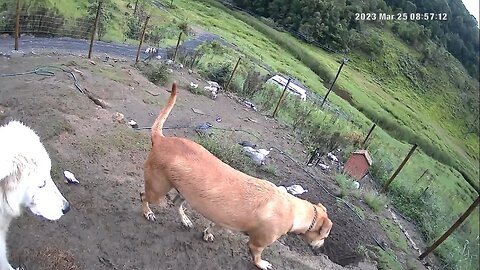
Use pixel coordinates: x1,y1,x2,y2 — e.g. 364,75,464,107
140,169,172,221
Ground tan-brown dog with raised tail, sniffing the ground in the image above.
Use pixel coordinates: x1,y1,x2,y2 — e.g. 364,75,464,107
140,83,332,269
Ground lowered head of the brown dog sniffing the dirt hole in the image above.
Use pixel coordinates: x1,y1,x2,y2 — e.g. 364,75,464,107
304,203,333,248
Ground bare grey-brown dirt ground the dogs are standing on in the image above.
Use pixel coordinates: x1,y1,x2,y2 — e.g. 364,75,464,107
0,55,432,270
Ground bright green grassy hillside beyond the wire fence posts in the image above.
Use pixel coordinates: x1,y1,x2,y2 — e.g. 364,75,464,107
0,0,479,269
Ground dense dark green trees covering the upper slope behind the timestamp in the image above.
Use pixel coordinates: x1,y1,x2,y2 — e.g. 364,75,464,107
233,0,480,79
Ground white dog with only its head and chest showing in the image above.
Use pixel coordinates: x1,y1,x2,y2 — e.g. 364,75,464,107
0,121,70,270
